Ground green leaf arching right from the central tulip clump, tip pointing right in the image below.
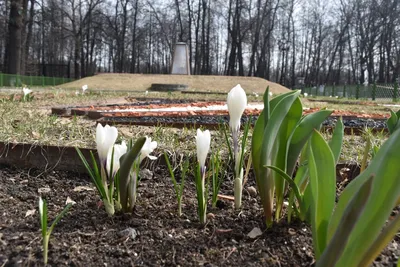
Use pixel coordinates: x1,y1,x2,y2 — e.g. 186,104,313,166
287,110,332,175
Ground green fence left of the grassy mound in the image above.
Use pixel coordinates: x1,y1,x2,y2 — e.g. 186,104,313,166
0,73,74,87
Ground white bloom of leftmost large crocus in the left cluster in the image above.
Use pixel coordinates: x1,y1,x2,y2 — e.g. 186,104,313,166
96,123,118,166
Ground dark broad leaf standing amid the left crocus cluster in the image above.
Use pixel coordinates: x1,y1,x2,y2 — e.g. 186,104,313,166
119,137,146,211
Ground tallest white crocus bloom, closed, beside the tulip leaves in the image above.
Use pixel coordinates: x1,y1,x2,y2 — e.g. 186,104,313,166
226,84,247,132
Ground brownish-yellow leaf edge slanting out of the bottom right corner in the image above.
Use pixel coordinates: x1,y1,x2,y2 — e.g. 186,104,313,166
358,213,400,267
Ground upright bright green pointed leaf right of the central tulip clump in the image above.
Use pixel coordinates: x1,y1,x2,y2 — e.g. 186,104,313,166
308,130,336,260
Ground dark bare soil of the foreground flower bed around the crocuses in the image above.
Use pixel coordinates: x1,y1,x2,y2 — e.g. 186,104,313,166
0,164,400,266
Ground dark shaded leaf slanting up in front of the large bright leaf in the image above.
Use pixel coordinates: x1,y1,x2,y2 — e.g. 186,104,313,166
316,176,373,267
